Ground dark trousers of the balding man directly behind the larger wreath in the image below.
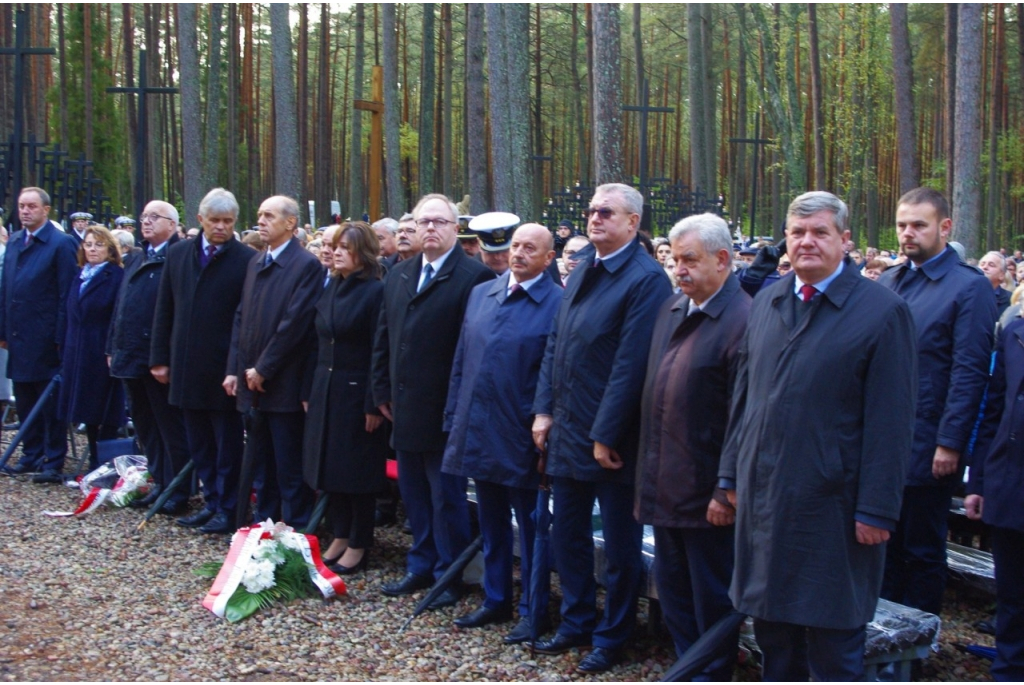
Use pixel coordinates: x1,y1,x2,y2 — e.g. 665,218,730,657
249,412,313,530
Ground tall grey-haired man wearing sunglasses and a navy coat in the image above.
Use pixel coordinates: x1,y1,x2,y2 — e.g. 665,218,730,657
532,183,672,673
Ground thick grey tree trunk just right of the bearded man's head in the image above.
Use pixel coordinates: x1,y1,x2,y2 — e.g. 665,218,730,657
952,2,982,257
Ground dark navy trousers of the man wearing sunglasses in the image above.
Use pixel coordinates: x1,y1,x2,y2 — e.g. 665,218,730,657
551,478,643,649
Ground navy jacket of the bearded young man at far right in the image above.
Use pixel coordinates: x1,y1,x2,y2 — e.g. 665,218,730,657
879,247,996,485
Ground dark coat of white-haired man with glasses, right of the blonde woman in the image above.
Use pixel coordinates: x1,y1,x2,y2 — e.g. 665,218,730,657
106,234,180,380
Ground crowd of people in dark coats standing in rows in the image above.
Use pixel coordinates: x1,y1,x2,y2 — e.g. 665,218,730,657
0,183,1024,680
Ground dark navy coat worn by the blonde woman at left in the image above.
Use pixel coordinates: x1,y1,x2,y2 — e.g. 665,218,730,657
57,263,125,426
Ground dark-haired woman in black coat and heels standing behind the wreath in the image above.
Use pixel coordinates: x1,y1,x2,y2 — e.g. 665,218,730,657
303,221,387,575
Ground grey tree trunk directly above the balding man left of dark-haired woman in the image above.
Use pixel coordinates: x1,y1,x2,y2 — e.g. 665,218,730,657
270,2,305,208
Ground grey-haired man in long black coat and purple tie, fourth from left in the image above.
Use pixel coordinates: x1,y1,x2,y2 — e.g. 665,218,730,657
150,188,253,533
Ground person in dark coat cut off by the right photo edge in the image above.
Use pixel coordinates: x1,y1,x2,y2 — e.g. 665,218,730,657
964,316,1024,682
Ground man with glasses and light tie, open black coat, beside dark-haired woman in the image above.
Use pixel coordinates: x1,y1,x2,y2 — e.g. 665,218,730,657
373,195,494,608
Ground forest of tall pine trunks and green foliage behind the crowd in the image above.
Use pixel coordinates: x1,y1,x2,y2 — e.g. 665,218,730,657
0,3,1011,256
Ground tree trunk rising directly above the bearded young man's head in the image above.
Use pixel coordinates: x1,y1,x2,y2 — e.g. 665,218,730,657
889,2,921,195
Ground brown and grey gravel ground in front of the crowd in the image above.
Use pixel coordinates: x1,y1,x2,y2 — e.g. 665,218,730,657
0,444,992,682
